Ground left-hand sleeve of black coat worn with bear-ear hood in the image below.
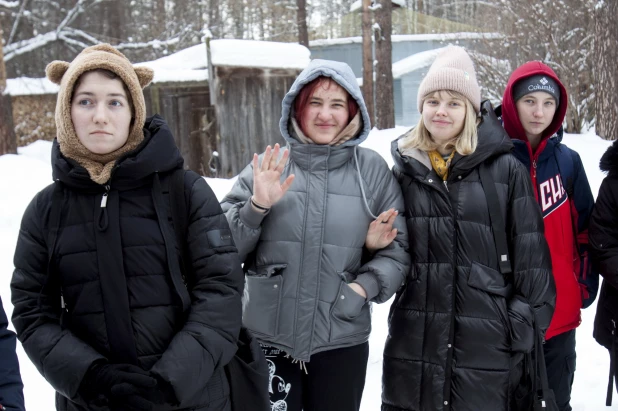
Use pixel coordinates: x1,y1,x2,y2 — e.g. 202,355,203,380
11,191,104,401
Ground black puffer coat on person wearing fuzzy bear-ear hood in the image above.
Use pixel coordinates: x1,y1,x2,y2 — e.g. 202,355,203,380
11,117,243,410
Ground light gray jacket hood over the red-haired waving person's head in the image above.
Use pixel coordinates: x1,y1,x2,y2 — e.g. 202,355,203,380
279,59,371,147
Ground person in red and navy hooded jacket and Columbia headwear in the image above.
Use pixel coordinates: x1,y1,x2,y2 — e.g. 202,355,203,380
498,61,599,411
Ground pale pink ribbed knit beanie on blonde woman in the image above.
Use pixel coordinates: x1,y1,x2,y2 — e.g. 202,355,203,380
418,46,481,113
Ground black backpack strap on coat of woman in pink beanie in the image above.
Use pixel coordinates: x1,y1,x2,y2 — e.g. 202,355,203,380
479,162,513,275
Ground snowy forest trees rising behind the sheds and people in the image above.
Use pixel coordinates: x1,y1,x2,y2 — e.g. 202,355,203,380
0,0,618,142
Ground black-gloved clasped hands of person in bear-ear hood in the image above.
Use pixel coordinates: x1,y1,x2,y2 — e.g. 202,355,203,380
81,363,162,411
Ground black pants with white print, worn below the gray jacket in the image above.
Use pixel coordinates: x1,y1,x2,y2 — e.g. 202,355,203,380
262,343,369,411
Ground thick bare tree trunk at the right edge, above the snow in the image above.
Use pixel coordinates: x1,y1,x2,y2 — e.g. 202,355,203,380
593,0,618,140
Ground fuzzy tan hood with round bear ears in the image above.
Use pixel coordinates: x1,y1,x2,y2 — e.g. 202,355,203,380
45,44,154,184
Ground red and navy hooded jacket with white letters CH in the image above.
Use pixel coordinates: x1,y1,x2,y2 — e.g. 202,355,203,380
497,61,599,339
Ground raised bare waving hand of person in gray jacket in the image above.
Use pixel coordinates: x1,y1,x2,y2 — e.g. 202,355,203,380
251,144,294,211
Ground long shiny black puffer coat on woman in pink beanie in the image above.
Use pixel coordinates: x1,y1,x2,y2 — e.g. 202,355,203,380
382,103,555,411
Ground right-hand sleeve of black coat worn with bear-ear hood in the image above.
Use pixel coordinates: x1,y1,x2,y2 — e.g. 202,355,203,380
152,178,244,407
